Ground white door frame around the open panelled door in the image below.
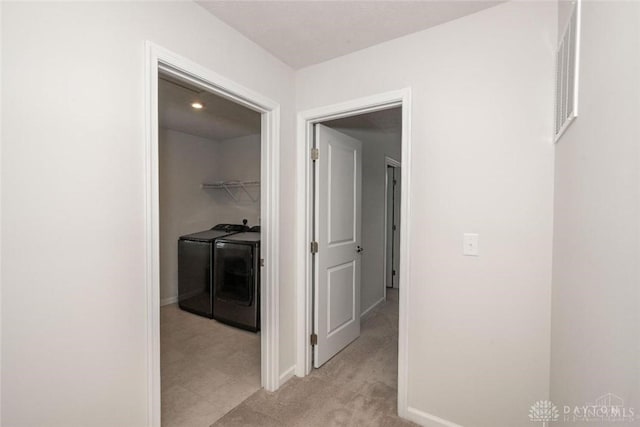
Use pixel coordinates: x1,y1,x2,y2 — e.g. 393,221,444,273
296,88,411,418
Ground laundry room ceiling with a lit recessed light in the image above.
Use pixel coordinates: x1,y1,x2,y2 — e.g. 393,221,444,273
158,76,260,141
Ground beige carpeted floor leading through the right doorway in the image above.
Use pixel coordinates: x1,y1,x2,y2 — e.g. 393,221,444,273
212,290,415,427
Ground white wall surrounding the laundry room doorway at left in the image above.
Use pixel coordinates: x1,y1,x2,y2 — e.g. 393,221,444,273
1,2,295,427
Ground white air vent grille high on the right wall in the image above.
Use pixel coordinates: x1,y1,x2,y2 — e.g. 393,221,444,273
554,1,580,142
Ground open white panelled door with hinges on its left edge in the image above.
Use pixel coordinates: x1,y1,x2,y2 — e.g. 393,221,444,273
314,124,362,368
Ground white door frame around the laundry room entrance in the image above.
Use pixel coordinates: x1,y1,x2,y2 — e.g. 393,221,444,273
144,41,280,427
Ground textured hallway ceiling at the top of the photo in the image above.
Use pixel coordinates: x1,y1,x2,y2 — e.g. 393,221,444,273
198,0,501,68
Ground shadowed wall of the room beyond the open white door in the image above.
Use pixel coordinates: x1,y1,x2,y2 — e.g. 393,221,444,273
328,128,402,313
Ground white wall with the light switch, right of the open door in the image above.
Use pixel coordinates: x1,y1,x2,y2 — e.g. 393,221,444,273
296,2,557,427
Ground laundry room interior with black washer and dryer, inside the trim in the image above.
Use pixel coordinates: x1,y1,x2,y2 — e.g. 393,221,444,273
158,73,261,426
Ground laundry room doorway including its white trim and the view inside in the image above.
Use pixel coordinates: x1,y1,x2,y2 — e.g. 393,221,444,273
146,43,279,427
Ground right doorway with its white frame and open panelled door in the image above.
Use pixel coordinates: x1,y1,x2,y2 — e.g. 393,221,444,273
296,90,410,416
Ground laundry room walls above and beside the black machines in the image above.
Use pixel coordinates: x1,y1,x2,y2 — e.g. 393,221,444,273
159,129,260,304
